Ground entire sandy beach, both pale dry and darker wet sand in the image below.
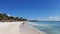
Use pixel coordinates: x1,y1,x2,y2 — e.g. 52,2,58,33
0,22,44,34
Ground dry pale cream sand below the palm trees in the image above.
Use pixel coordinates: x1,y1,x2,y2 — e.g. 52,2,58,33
0,22,22,34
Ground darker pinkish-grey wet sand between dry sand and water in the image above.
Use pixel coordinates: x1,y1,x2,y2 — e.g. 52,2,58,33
20,24,46,34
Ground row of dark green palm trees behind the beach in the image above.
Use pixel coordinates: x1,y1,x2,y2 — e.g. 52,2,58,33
0,13,27,21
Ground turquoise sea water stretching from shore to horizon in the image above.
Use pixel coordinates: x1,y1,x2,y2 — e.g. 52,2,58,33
28,21,60,34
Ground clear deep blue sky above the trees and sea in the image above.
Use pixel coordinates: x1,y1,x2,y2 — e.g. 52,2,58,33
0,0,60,20
